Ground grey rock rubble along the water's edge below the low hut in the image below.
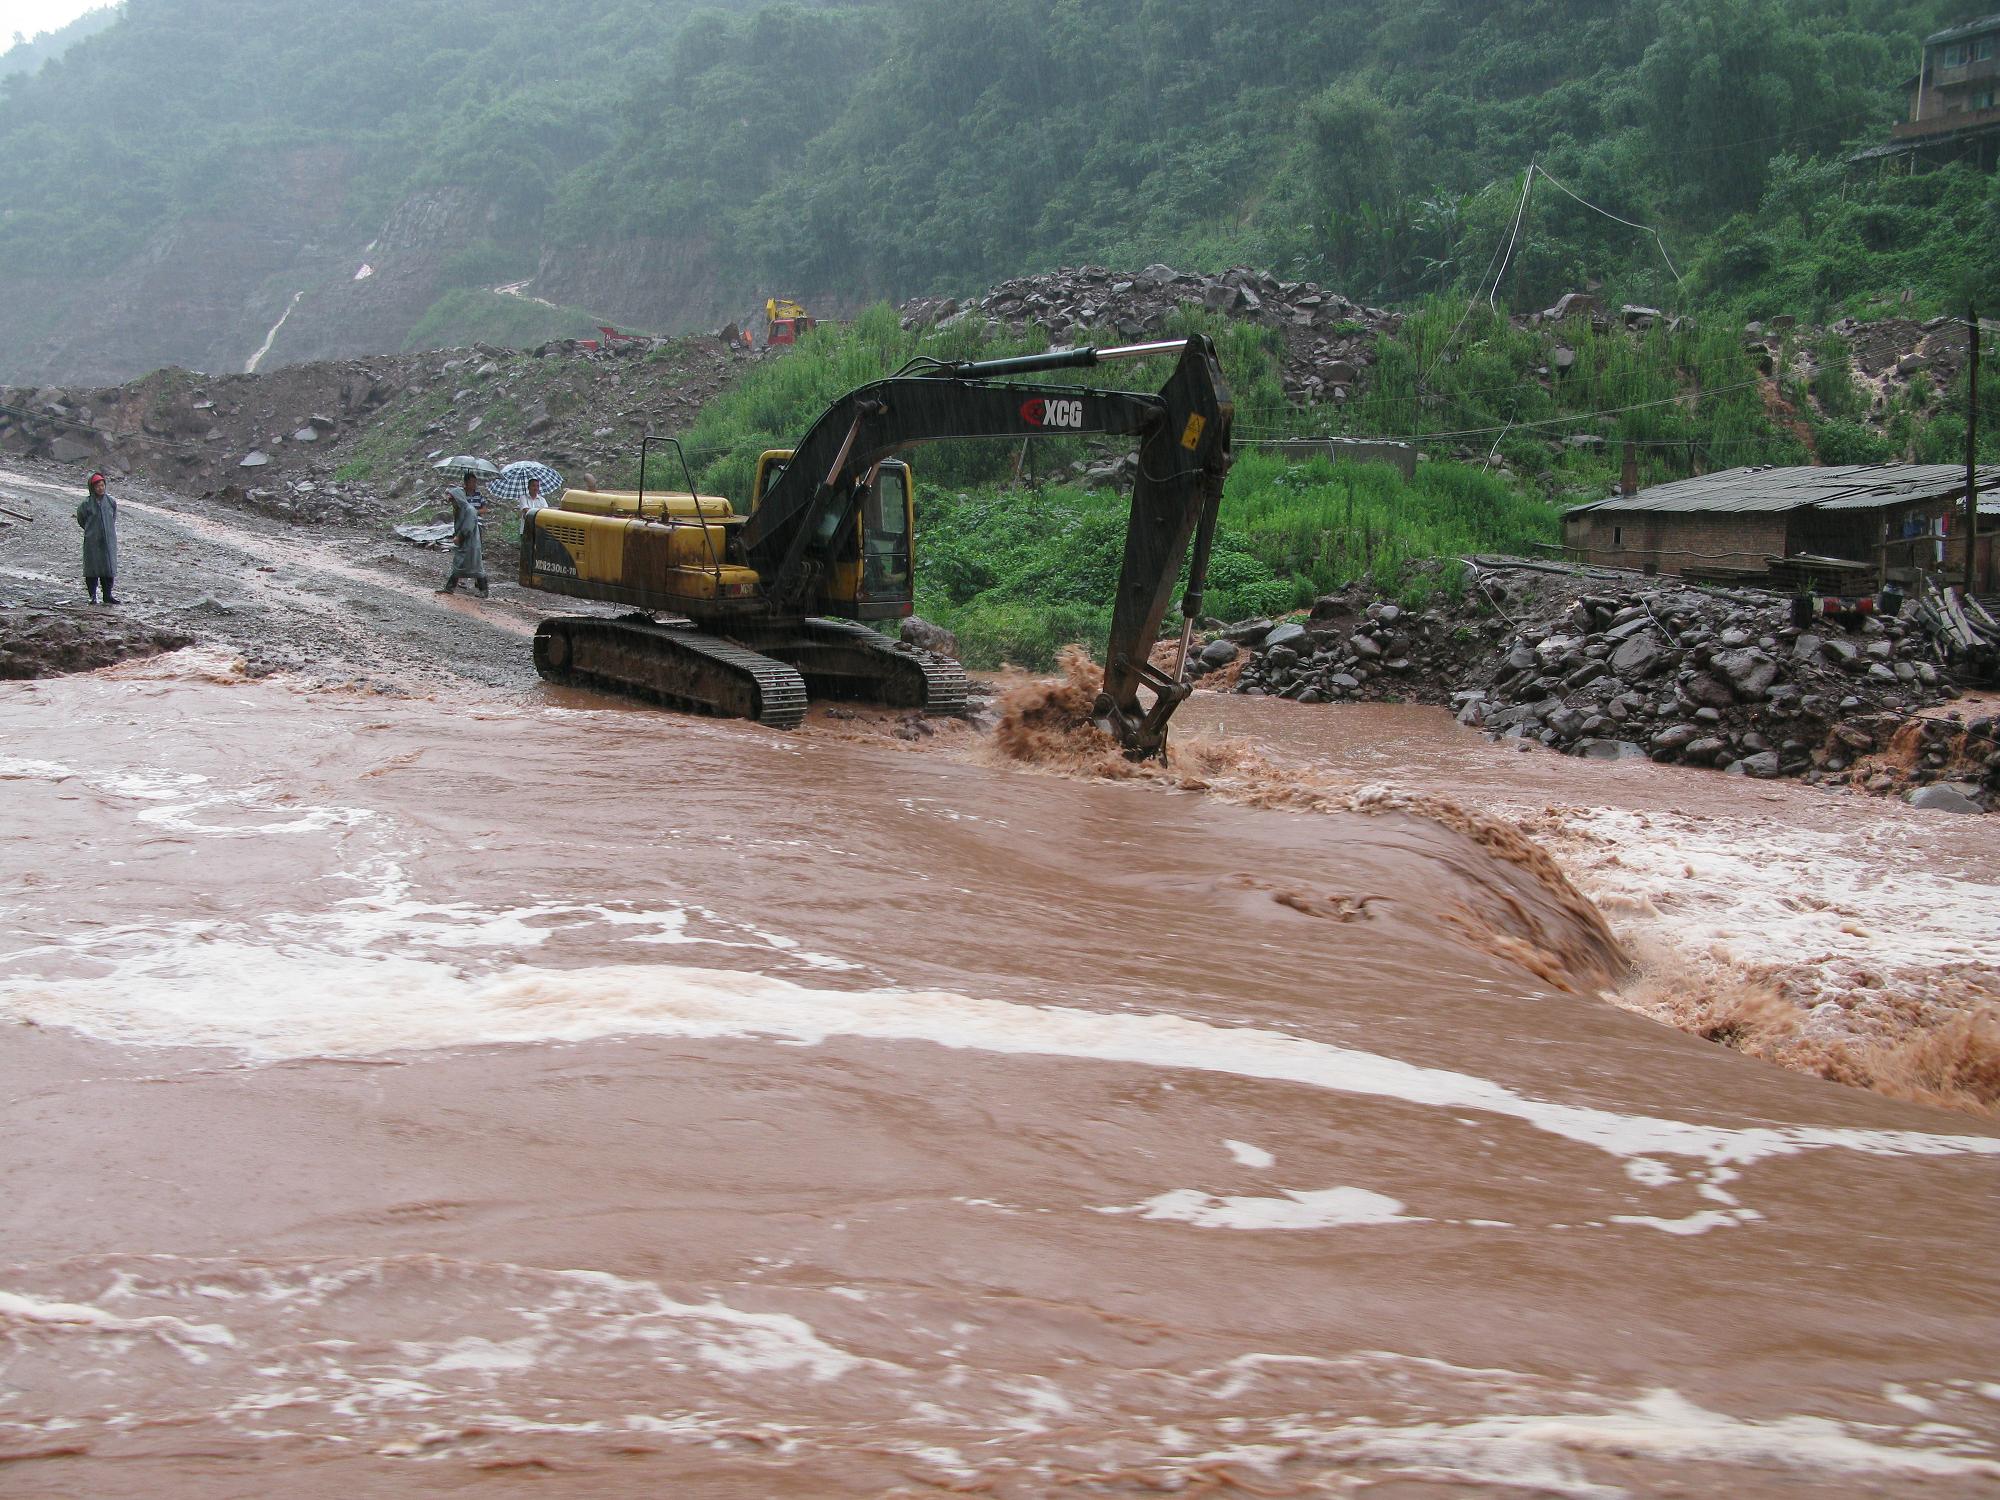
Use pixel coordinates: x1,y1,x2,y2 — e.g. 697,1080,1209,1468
1194,564,2000,810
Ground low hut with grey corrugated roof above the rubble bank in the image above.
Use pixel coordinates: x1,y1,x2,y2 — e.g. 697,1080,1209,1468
1562,464,2000,594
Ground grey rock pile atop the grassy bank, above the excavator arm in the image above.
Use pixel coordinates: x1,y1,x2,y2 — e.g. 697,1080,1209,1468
900,266,1402,402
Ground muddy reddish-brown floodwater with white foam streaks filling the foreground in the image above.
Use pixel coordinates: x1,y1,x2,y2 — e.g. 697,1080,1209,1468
0,652,2000,1500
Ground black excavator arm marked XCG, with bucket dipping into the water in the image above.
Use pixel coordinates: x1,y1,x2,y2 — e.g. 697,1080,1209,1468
742,336,1234,756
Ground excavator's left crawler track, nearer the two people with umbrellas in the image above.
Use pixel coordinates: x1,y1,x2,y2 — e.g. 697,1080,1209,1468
534,616,806,730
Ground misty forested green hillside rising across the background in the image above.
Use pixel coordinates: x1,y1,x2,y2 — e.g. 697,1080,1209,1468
0,0,2000,312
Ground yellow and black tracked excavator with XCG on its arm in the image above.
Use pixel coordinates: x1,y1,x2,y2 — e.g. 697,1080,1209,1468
520,336,1234,758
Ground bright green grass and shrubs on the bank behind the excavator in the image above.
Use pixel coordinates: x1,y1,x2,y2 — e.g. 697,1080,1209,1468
620,298,2000,666
